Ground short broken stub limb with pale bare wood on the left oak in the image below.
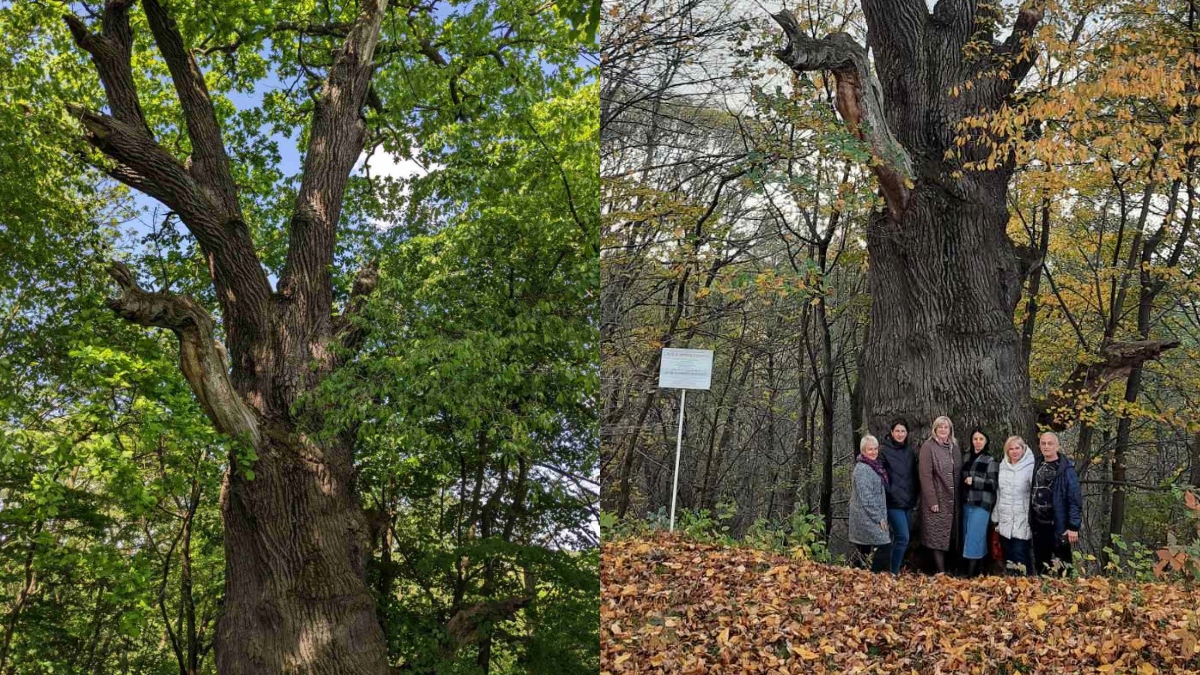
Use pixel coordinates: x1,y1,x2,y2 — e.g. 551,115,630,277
108,263,259,447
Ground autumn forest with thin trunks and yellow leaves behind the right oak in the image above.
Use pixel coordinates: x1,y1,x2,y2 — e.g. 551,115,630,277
599,0,1200,573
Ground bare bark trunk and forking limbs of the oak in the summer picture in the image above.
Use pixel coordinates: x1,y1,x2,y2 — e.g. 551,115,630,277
65,0,388,675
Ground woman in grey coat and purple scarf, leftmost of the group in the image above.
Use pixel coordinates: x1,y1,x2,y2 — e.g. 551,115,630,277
850,435,892,572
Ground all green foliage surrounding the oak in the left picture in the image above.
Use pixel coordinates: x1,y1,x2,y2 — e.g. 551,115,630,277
0,0,599,675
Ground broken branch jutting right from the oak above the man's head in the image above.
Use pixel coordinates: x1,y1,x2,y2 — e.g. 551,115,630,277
1033,340,1180,431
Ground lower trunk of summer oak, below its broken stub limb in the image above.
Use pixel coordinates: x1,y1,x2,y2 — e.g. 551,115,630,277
216,429,388,675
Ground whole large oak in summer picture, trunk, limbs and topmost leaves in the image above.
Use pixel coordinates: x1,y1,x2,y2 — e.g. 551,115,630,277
52,0,594,675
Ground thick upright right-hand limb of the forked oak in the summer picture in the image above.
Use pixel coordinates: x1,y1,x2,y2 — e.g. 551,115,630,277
280,0,388,327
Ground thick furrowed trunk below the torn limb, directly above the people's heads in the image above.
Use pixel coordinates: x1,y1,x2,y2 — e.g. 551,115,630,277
860,180,1034,438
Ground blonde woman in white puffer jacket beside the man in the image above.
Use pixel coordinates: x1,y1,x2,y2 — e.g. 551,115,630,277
991,436,1034,574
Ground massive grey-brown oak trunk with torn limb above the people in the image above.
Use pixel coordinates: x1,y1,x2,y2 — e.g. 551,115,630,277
774,0,1171,437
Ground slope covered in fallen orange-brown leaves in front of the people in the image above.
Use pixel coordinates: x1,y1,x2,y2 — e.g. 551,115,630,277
601,536,1200,675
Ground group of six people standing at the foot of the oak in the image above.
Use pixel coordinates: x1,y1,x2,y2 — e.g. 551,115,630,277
850,416,1082,575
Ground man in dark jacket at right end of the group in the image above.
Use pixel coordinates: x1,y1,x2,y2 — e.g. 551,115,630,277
1030,431,1084,573
